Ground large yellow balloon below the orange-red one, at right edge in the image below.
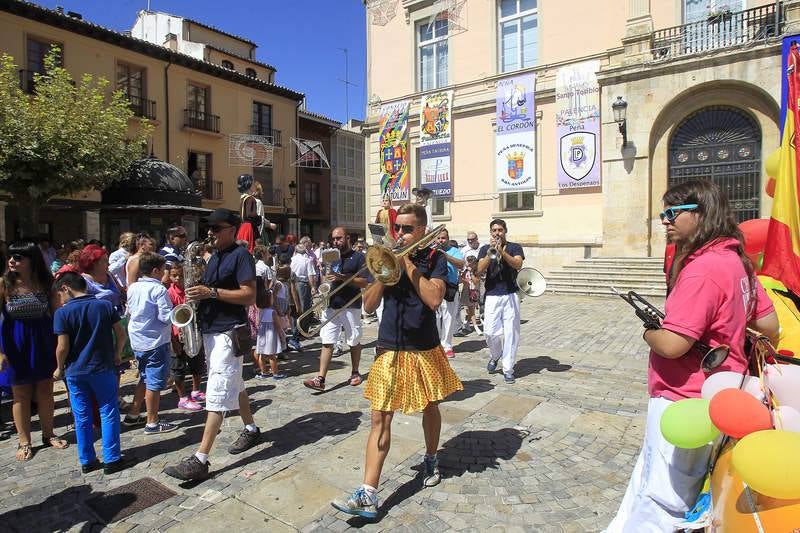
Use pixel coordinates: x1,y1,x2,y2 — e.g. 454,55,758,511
731,429,800,500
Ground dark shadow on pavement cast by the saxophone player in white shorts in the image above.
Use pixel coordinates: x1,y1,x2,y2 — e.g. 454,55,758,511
211,411,363,477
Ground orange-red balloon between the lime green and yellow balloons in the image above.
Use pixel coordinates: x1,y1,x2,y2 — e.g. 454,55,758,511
708,389,772,439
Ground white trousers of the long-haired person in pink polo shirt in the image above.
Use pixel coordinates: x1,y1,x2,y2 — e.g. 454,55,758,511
606,398,712,533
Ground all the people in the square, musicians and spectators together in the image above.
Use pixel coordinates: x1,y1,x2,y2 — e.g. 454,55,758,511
0,176,778,531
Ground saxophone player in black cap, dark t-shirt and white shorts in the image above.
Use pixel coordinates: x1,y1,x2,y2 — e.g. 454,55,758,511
164,208,261,480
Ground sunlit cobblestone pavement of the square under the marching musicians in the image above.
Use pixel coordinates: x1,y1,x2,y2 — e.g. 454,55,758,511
0,295,662,533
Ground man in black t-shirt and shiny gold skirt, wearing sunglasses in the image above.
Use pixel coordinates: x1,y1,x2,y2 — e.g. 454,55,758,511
331,204,463,518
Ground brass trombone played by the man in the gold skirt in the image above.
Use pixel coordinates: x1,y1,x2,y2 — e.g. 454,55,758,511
297,224,445,337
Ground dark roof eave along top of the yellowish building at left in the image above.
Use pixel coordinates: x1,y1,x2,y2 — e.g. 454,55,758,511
0,0,304,102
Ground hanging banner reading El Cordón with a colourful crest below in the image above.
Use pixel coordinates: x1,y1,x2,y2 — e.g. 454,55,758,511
495,74,536,193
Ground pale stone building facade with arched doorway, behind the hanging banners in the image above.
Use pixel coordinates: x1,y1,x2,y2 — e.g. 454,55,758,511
364,0,800,272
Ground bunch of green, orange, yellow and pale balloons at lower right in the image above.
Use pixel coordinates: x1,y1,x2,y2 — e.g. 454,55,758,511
661,338,800,499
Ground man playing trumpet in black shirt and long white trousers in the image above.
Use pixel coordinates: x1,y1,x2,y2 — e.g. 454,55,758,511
478,218,525,384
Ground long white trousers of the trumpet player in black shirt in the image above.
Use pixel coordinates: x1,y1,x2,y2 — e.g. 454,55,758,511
483,293,519,373
